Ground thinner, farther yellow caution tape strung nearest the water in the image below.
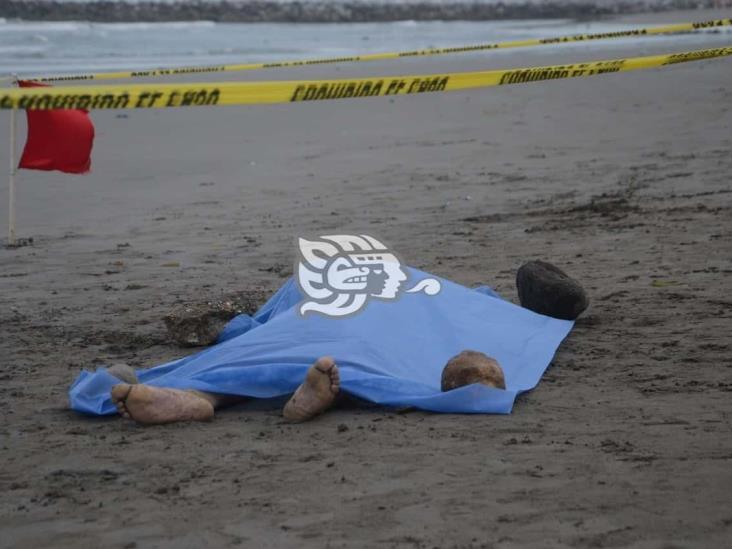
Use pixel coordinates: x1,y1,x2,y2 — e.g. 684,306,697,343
14,19,732,82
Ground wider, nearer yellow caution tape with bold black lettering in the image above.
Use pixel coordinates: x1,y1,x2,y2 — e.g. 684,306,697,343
0,46,732,109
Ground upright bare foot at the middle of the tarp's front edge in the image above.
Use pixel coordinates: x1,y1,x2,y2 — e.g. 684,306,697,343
282,356,341,421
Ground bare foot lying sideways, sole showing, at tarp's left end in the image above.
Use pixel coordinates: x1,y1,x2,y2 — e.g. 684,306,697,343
112,383,214,425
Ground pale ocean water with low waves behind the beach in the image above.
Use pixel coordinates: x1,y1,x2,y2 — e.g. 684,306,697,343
0,18,732,76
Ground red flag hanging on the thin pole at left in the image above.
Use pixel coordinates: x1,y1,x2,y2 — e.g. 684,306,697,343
18,80,94,173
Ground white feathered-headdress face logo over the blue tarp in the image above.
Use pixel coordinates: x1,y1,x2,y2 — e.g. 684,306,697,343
297,234,440,317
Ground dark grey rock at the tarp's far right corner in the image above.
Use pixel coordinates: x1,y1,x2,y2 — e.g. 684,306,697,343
516,261,590,320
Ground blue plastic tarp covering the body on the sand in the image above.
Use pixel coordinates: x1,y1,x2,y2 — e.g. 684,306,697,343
69,269,573,415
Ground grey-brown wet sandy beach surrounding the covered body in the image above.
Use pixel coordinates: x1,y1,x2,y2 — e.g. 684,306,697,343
0,10,732,549
